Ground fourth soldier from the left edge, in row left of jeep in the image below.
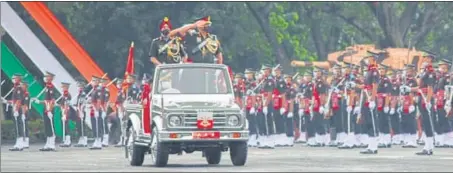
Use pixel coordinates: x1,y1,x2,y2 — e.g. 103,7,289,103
74,80,91,147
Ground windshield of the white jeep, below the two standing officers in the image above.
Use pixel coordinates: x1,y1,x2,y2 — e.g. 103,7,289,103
154,67,232,94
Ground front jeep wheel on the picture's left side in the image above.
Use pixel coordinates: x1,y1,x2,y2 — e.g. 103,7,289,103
151,127,169,167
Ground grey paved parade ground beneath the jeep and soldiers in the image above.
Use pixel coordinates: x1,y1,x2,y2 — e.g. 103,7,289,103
1,144,453,172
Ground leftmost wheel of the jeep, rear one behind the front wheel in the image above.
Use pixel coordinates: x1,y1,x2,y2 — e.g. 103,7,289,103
125,128,147,166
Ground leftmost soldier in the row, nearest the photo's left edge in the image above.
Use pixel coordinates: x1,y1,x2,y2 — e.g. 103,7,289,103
9,73,28,151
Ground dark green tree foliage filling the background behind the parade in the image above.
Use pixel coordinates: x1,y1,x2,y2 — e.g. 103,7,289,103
5,1,453,77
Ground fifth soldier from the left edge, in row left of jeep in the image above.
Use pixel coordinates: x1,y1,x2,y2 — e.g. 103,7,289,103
97,79,110,147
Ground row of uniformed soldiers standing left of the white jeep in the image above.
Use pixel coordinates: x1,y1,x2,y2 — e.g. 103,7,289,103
3,72,152,151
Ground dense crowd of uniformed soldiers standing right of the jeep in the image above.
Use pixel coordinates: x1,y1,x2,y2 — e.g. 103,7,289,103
234,52,453,155
